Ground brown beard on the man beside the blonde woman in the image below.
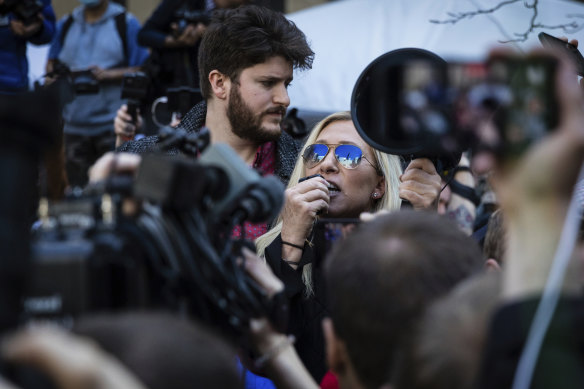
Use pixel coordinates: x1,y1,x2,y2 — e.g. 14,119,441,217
227,84,286,144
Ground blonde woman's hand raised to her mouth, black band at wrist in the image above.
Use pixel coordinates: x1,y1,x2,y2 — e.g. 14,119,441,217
281,177,330,261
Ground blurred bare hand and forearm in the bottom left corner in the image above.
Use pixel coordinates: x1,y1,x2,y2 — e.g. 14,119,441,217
2,328,145,389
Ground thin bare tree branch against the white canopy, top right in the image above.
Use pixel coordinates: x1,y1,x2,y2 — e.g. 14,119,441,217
430,0,584,43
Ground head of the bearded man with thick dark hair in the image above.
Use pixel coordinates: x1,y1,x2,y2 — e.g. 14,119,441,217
199,5,314,142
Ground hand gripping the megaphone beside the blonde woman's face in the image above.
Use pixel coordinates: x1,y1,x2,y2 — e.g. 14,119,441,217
399,158,441,210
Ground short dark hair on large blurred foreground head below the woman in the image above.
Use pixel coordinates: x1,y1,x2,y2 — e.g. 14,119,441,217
325,211,482,388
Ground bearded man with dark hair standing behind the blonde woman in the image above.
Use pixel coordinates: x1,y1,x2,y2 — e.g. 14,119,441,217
118,6,314,239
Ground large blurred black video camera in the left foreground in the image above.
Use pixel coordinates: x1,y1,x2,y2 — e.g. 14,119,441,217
24,123,286,338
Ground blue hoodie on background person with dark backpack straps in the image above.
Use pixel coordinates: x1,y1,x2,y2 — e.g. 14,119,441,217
49,2,148,135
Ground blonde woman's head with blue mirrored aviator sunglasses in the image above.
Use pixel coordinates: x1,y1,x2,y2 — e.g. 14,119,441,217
290,112,402,217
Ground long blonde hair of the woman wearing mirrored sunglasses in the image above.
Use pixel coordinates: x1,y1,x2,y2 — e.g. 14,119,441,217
255,111,402,295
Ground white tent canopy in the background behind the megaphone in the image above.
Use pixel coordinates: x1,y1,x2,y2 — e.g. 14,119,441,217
288,0,584,112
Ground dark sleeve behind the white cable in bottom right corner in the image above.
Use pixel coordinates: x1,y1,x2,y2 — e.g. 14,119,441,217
477,297,584,389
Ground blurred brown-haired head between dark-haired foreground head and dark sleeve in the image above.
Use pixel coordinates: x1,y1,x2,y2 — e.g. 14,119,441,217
392,273,501,389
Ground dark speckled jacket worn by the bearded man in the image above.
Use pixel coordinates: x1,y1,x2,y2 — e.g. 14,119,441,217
117,102,302,185
